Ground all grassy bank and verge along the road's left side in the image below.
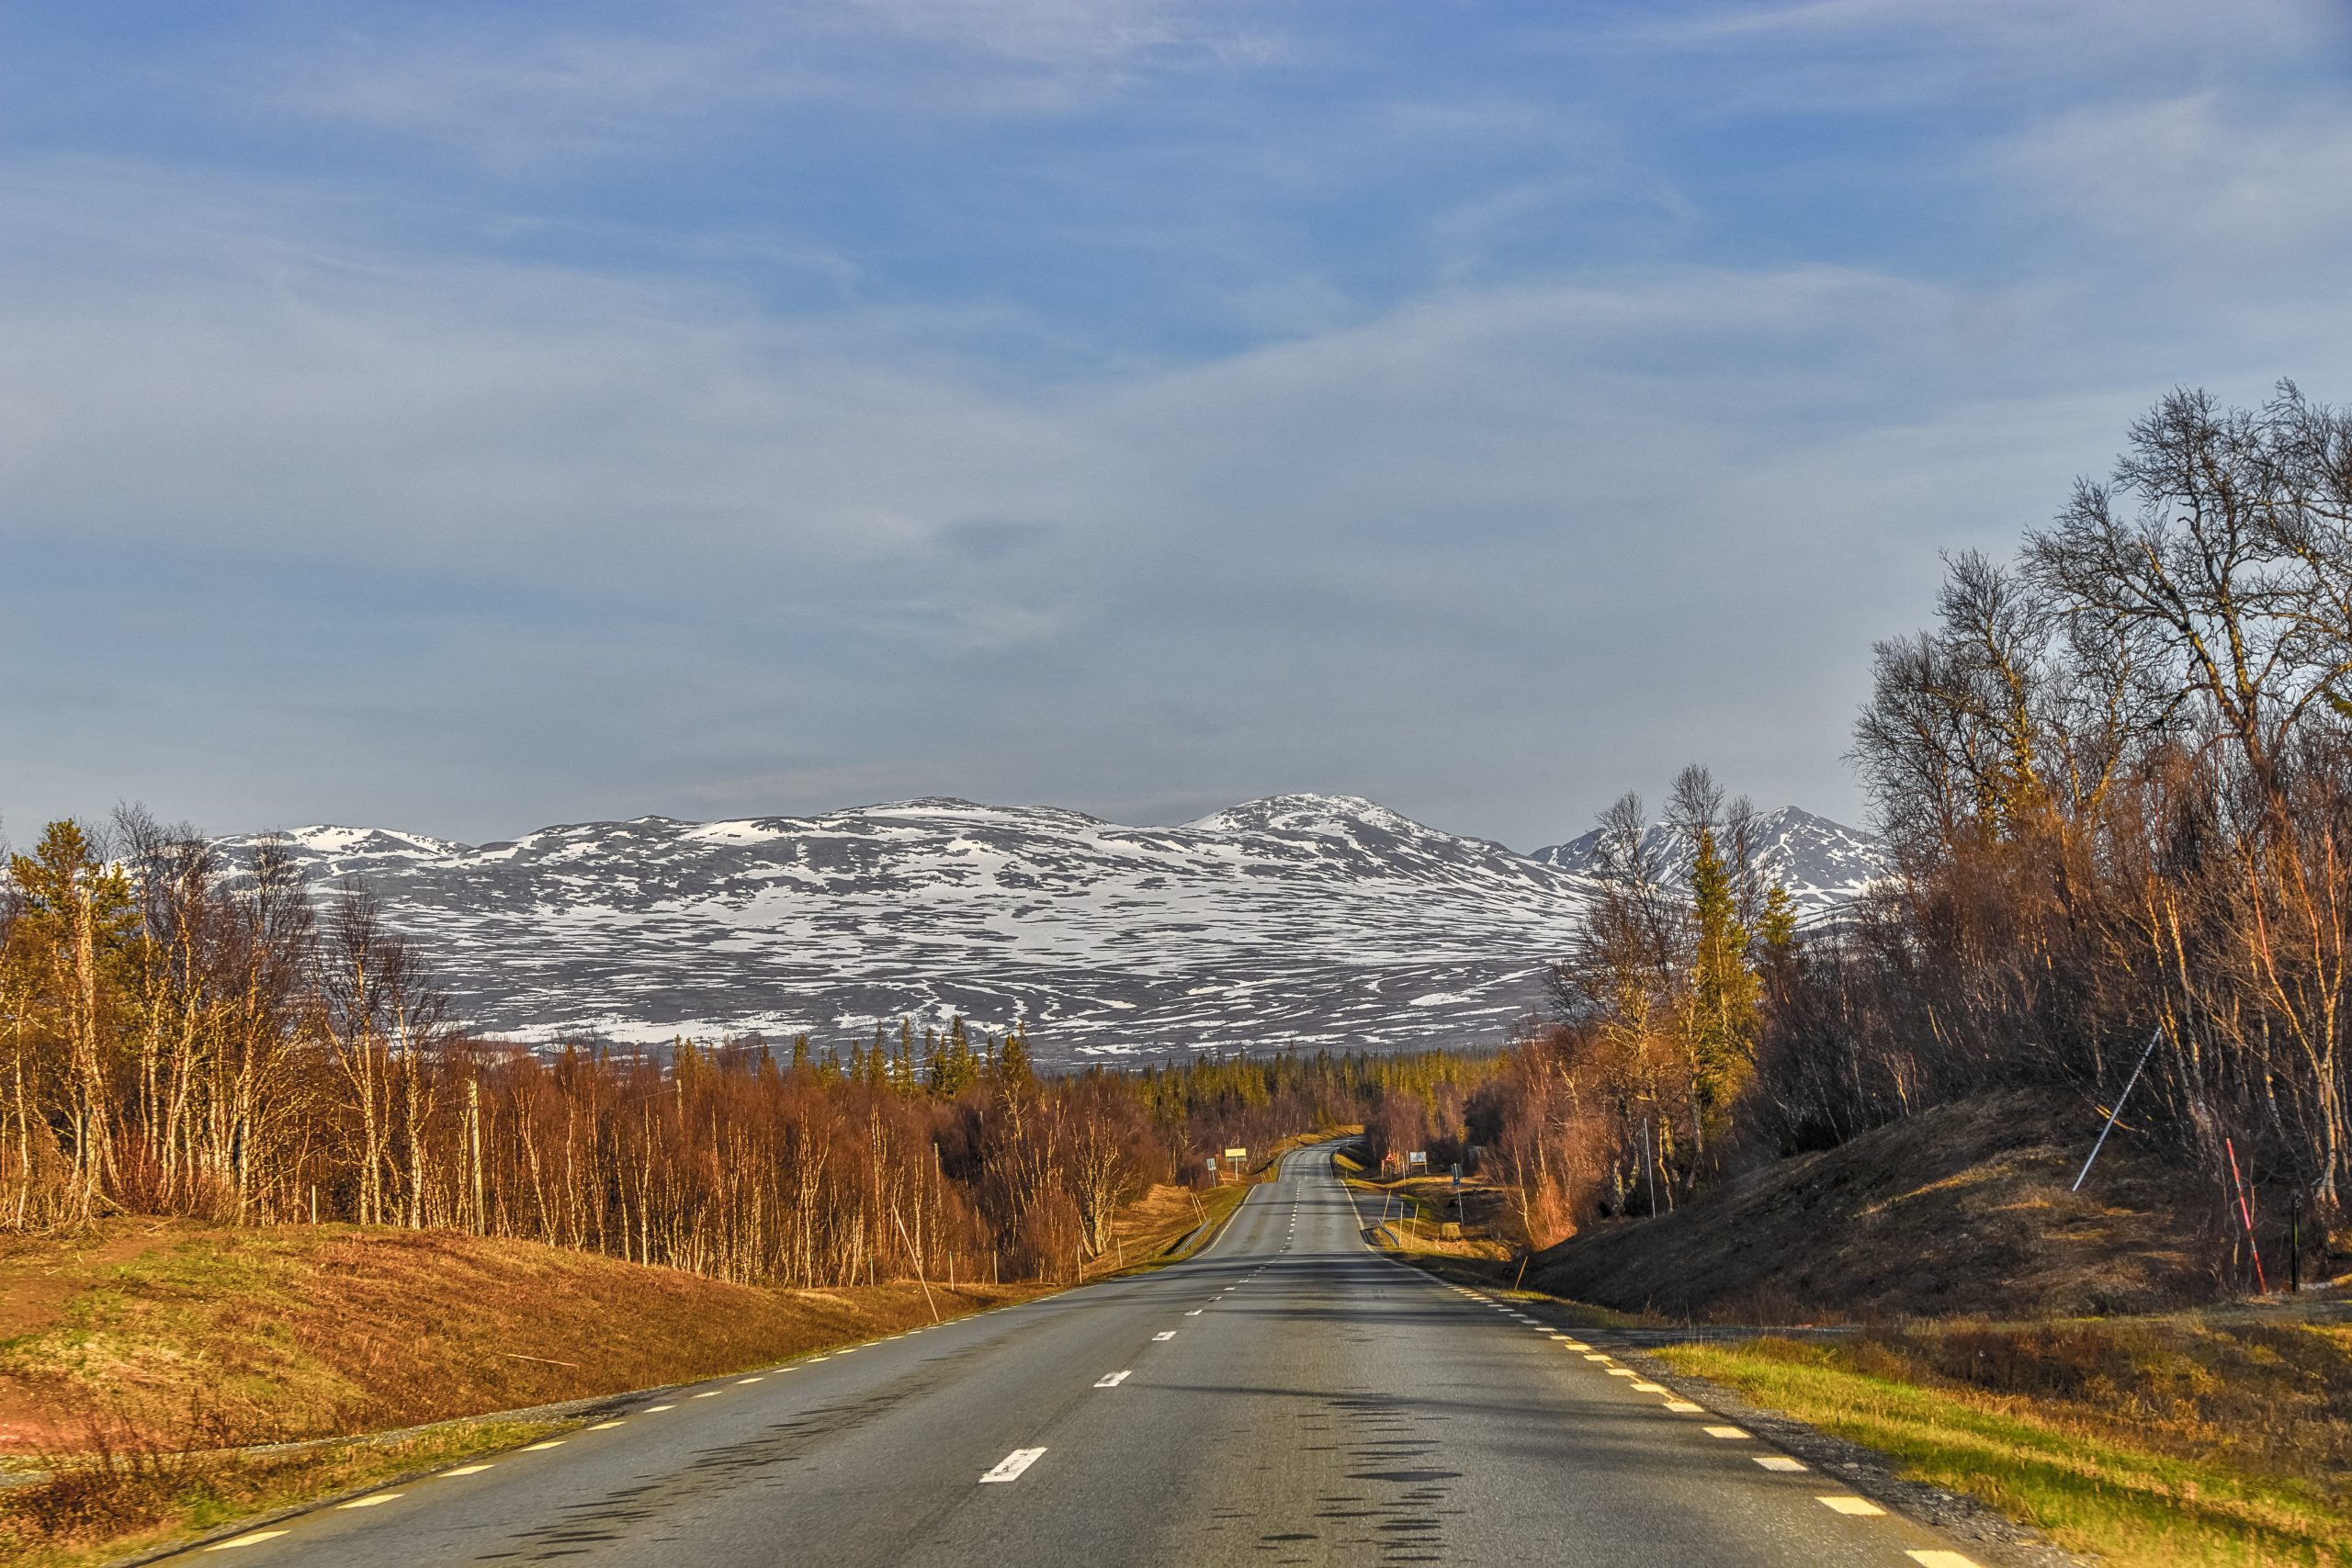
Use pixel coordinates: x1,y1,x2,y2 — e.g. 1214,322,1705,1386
0,1185,1247,1568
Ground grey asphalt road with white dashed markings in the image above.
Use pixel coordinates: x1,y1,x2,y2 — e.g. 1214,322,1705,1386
187,1149,1966,1568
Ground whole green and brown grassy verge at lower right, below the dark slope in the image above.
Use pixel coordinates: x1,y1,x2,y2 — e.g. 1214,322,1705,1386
1660,1316,2352,1568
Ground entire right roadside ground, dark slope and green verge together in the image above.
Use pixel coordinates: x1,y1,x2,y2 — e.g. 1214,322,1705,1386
1357,1096,2352,1568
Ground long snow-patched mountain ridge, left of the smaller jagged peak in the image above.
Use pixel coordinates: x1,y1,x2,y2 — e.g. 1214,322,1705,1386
226,795,1871,1063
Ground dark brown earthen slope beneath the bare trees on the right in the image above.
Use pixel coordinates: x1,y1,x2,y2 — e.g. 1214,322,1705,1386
1526,1093,2218,1324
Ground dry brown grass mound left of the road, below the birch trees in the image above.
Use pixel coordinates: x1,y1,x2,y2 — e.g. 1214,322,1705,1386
0,1224,1035,1458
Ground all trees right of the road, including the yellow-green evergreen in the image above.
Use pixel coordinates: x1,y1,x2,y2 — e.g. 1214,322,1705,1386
1467,383,2352,1279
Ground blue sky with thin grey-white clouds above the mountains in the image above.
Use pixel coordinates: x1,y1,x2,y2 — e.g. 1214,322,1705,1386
0,0,2352,846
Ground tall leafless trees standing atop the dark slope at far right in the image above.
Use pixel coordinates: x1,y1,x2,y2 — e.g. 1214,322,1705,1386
1759,386,2352,1218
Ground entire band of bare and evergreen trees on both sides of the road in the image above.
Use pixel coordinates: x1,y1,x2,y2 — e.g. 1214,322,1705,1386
14,386,2352,1283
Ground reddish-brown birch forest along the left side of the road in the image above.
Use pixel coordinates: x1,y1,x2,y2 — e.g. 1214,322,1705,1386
0,811,1491,1286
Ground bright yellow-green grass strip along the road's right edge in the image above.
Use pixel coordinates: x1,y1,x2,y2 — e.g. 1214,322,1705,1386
1658,1340,2352,1568
